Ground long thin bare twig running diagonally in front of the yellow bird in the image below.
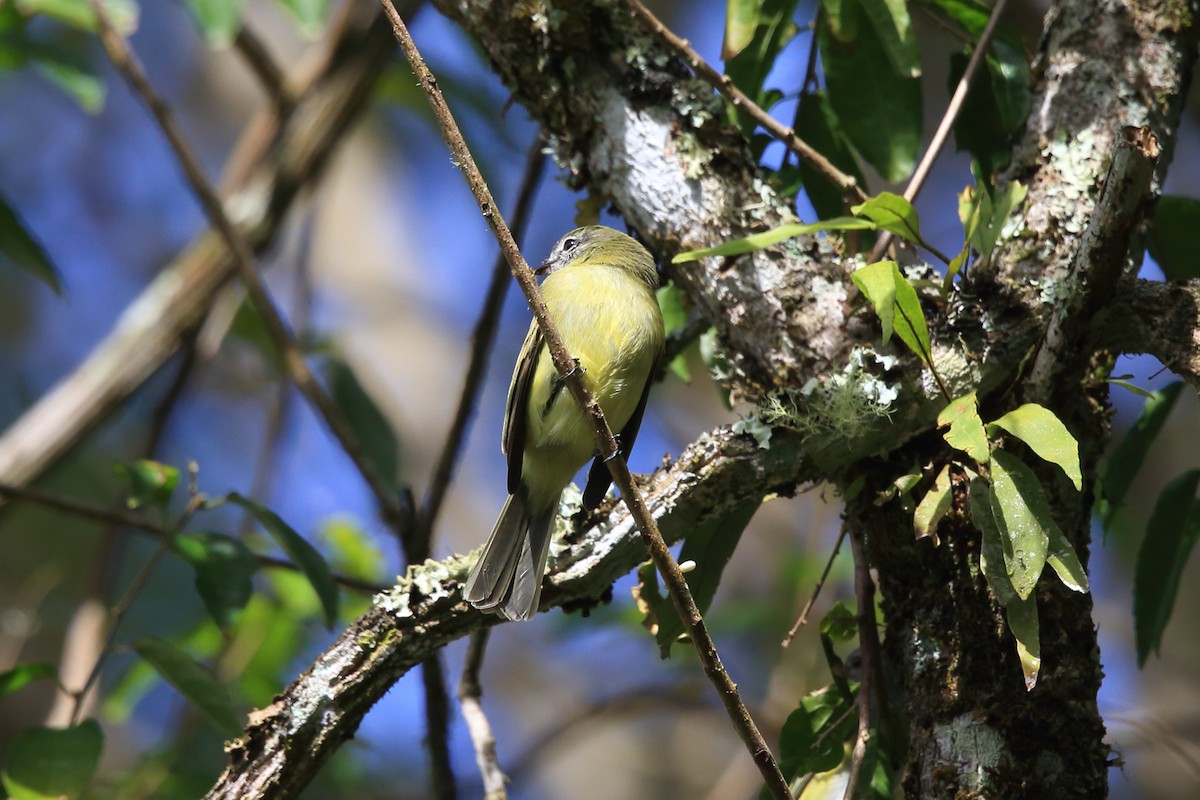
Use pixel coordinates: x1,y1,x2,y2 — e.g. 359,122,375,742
382,0,790,800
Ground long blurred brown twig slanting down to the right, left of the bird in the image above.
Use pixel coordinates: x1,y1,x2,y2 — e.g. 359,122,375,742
89,0,409,537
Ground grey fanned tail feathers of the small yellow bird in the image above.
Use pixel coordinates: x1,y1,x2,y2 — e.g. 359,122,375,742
463,488,558,620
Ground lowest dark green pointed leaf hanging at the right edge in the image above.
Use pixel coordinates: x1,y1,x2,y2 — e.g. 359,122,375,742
1133,469,1200,667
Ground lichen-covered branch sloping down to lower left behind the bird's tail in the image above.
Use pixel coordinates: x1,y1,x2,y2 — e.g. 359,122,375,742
206,428,799,800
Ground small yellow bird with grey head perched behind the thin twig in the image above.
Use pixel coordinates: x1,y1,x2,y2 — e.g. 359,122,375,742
463,225,664,619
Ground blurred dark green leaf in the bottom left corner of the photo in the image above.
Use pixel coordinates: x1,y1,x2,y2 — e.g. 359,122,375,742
0,720,104,800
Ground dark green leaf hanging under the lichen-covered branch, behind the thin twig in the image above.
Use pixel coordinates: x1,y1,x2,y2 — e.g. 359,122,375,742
655,500,761,658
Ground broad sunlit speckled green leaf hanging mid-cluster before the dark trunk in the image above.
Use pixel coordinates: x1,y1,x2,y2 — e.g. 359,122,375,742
991,450,1055,600
